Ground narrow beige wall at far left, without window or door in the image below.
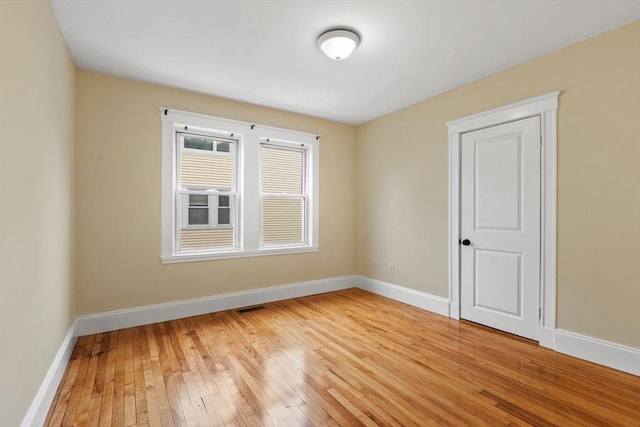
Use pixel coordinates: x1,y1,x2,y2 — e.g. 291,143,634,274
0,0,75,427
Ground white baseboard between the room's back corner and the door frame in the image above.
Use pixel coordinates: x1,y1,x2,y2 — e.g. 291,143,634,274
357,276,449,317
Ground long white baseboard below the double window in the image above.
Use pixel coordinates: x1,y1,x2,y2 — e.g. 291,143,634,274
78,276,358,336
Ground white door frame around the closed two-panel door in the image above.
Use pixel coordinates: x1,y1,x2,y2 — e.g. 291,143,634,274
447,91,560,348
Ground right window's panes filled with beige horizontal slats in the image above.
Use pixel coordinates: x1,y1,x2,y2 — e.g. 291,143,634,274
260,144,306,245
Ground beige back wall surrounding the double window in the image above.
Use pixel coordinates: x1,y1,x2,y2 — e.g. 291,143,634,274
76,71,355,314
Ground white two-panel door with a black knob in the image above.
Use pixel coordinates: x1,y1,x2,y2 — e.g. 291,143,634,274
460,117,541,340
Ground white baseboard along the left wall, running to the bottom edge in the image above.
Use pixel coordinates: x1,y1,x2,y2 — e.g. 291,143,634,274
20,320,78,427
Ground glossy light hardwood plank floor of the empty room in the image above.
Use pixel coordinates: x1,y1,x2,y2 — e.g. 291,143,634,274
46,289,640,427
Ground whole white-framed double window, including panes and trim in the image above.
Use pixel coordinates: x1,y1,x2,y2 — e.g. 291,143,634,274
161,108,319,262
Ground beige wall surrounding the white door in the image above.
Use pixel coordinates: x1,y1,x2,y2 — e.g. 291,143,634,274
356,22,640,347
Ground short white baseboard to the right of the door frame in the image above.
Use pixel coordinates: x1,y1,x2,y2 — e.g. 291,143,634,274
554,329,640,376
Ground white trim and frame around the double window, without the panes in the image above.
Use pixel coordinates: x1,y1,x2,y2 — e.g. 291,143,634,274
160,107,320,264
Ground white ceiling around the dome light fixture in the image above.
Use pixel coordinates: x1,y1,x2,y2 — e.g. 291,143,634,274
51,0,640,124
